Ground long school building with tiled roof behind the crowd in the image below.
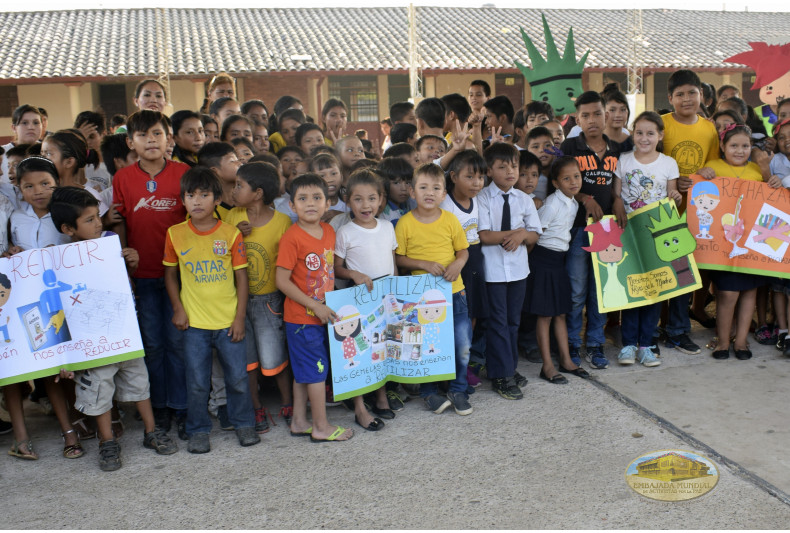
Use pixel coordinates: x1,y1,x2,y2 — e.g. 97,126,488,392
0,7,790,142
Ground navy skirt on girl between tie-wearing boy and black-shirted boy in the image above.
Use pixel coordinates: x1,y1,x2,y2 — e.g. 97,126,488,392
524,246,571,316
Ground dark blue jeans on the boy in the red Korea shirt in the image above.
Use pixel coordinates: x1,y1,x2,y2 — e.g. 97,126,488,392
134,278,187,409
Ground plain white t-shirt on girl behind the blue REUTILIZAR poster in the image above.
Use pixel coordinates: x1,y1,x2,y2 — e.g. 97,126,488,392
335,219,398,279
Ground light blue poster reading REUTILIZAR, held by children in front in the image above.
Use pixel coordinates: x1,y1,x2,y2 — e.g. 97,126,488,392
326,274,455,400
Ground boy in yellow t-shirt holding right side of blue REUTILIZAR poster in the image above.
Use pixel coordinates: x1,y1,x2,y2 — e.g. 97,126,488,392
395,163,472,415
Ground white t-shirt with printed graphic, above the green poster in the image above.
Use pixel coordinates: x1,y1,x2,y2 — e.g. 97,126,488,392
615,152,680,213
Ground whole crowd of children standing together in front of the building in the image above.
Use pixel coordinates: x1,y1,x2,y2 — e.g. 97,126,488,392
0,70,790,470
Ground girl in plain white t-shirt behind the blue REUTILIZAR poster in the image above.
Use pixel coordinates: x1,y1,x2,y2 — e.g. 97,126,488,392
335,169,398,431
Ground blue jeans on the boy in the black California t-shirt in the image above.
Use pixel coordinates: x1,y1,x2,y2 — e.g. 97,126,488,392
565,227,606,348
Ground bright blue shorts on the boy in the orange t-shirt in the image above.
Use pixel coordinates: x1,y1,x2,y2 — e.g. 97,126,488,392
285,322,329,383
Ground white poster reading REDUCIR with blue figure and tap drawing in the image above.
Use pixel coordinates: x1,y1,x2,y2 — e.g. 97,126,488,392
0,236,144,386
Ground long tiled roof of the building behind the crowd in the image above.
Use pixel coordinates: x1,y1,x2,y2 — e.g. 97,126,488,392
0,7,790,79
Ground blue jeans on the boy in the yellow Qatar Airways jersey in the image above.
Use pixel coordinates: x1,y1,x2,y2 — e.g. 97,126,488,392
184,327,255,435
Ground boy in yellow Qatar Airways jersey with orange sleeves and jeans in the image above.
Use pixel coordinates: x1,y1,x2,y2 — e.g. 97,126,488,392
162,166,261,453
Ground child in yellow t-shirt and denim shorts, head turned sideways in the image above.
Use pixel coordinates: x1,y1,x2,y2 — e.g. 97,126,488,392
227,162,293,433
